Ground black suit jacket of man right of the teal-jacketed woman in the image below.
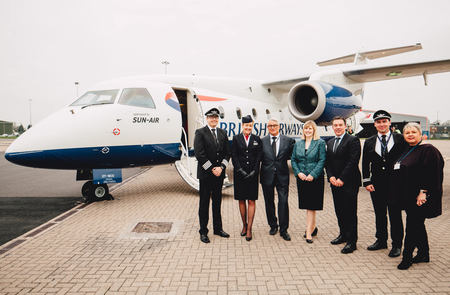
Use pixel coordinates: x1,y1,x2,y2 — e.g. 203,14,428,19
325,134,361,186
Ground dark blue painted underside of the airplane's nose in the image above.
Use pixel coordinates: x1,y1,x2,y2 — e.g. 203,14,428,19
5,143,181,170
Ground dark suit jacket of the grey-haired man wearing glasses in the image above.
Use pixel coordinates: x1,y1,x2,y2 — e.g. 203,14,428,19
260,134,295,185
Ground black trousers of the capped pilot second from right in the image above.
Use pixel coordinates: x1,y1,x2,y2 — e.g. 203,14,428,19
370,183,403,248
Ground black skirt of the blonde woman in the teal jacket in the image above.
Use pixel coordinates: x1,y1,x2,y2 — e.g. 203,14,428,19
296,175,324,210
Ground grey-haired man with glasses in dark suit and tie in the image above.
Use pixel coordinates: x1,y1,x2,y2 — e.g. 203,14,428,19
260,118,295,241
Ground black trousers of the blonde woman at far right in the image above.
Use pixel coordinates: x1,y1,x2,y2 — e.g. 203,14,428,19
403,206,430,260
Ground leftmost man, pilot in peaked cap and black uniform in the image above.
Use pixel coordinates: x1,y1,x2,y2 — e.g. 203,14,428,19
194,108,230,243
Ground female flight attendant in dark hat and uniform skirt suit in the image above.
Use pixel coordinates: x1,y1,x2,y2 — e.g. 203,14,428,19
231,115,262,241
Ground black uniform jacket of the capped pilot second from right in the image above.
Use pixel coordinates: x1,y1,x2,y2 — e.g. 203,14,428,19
362,133,406,186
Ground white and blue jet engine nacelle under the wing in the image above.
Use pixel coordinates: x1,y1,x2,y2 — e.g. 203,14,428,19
288,81,362,125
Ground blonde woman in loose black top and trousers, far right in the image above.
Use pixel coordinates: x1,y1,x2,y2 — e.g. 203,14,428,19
391,123,444,269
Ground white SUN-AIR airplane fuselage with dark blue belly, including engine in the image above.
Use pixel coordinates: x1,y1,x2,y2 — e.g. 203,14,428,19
5,72,363,169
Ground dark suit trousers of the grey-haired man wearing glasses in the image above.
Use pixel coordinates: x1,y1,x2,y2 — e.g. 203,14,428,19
262,177,289,233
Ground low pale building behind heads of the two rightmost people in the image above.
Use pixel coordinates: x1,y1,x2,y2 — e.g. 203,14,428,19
357,110,430,138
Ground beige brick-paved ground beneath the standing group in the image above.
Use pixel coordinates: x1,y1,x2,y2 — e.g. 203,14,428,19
0,141,450,295
